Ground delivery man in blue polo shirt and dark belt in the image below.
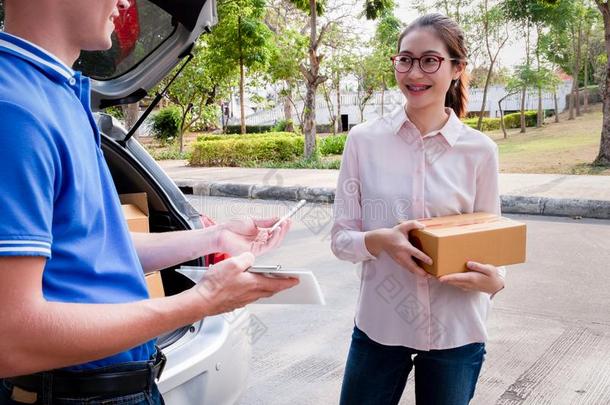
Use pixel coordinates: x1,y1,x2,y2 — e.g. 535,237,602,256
0,0,297,405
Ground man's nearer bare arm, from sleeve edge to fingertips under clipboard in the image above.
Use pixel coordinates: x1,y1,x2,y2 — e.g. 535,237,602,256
0,253,297,378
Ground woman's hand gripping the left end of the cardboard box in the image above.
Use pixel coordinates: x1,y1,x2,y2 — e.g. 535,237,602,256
365,221,432,278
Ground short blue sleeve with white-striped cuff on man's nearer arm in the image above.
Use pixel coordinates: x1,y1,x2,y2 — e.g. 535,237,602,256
0,101,59,258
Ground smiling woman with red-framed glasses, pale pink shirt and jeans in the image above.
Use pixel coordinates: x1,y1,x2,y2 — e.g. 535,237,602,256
332,14,504,405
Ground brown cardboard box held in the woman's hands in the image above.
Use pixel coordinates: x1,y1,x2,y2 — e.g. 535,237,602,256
409,212,526,277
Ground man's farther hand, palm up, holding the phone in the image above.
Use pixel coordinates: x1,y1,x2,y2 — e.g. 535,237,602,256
218,218,291,256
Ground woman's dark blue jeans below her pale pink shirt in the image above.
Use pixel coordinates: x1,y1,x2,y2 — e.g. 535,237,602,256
340,327,485,405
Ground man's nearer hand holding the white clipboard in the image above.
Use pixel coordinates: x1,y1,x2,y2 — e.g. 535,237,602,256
191,253,299,316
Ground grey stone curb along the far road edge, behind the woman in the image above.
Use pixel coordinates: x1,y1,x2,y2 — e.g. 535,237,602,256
176,180,610,219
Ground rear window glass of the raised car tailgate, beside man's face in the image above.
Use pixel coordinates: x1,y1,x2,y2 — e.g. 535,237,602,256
74,0,177,80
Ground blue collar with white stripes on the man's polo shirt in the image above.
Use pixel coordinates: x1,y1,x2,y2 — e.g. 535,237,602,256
0,32,75,81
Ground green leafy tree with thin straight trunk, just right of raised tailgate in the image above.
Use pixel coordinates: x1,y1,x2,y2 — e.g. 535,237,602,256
209,0,272,134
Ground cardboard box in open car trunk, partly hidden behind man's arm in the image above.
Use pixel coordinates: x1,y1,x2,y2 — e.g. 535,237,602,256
119,193,165,298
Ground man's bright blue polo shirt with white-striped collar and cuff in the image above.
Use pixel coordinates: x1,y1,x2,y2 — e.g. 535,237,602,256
0,33,155,370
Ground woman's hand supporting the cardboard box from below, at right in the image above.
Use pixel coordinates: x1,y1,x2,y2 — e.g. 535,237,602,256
438,261,504,294
